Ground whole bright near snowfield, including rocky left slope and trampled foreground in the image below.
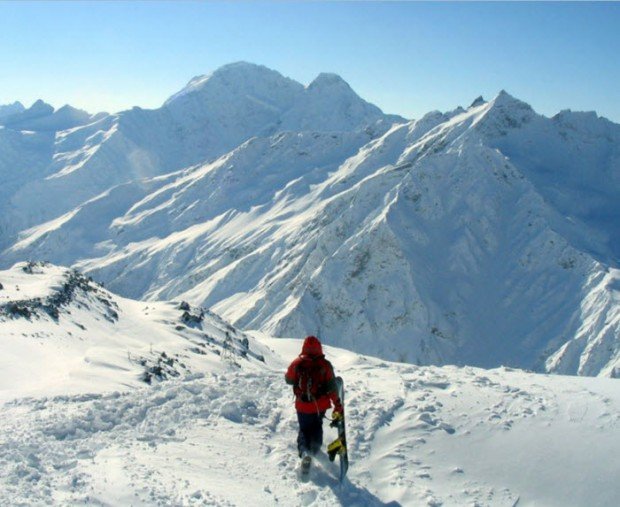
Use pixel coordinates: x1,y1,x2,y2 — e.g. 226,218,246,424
0,263,620,506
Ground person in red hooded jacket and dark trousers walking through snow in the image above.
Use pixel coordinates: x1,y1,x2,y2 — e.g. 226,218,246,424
284,336,343,459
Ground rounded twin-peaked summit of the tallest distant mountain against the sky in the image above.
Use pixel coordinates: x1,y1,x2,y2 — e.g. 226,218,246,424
164,62,404,137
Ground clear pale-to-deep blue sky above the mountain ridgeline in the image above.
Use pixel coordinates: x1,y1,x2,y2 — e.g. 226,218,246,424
0,1,620,123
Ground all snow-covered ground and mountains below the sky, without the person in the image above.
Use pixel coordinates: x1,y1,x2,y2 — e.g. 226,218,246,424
0,62,620,507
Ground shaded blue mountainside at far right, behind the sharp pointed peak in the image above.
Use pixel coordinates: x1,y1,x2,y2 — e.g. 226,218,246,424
480,92,620,267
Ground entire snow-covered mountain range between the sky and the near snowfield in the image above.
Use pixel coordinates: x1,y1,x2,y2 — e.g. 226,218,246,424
0,63,620,376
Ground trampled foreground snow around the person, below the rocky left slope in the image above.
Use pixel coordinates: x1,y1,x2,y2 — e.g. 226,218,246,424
0,340,620,506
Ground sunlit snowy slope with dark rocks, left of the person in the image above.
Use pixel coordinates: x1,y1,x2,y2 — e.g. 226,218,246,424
0,263,264,400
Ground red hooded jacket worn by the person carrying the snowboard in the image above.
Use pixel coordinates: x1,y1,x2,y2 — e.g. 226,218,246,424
284,336,342,414
